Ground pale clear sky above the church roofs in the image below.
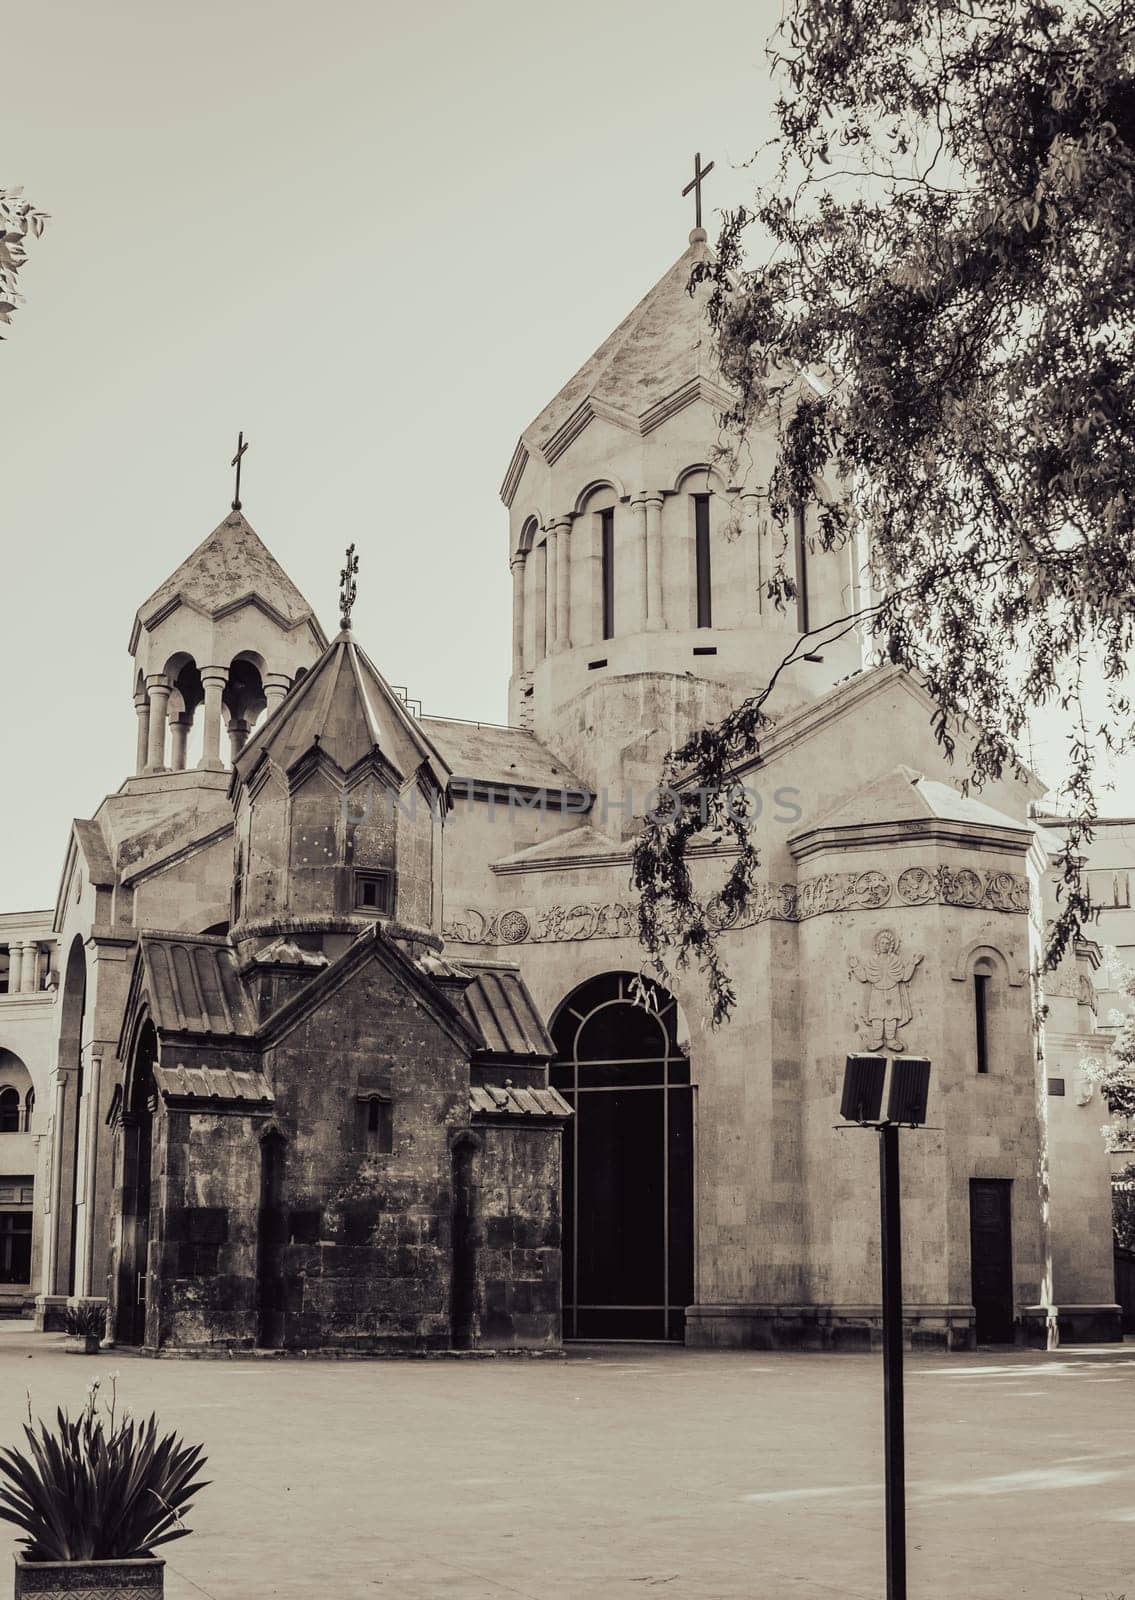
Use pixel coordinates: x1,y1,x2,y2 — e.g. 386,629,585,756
0,0,1126,909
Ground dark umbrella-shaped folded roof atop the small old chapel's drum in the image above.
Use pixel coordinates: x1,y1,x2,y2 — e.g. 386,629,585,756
234,629,450,790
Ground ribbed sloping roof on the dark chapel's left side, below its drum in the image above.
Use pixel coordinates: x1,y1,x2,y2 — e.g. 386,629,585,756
139,933,256,1038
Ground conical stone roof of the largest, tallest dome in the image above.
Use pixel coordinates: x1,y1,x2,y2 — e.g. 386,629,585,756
503,229,722,480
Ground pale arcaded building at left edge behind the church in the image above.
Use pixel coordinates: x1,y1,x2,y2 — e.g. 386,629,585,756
0,910,58,1317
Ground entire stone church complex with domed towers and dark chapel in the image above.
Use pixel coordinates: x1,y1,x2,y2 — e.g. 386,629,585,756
8,229,1119,1352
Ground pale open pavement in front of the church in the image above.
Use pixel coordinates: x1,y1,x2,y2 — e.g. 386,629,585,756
0,1323,1135,1600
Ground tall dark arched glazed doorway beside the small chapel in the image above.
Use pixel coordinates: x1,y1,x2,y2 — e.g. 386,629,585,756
551,973,693,1342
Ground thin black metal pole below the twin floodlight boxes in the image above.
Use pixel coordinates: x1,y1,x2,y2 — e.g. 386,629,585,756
879,1122,906,1600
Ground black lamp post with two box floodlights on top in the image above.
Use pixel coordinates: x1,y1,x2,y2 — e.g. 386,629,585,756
839,1054,930,1600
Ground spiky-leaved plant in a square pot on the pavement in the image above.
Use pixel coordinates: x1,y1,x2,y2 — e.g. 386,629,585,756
0,1379,205,1600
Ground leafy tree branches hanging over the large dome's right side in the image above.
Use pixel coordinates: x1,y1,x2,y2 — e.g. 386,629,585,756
634,0,1135,1019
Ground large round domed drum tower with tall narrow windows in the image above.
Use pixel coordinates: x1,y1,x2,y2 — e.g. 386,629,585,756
501,225,861,819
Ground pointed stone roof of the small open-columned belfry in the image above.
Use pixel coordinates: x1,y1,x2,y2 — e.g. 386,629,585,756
138,510,323,642
